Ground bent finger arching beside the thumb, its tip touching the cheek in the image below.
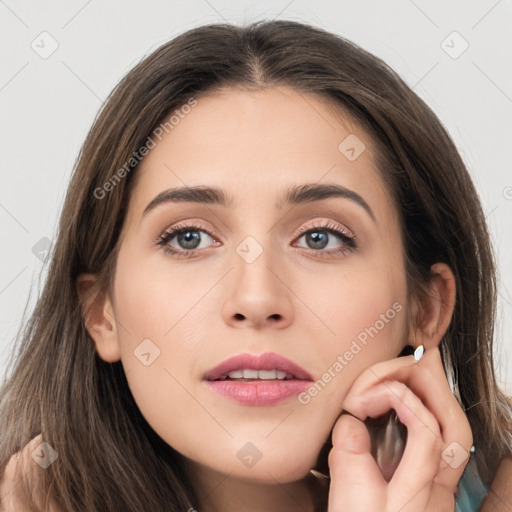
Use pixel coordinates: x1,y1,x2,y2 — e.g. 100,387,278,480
344,381,443,512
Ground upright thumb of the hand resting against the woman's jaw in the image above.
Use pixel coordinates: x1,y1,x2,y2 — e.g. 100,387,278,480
328,414,386,512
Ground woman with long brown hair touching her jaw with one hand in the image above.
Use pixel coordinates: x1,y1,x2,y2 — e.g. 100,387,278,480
0,21,512,512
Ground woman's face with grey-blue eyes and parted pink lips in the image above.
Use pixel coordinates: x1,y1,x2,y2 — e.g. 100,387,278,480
104,87,408,483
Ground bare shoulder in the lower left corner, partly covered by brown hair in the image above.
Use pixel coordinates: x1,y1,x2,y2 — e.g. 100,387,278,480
0,434,61,512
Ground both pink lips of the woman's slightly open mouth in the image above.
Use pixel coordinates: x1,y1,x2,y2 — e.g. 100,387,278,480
203,352,313,406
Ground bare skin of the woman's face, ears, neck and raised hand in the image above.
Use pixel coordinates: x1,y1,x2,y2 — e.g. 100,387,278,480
78,87,472,512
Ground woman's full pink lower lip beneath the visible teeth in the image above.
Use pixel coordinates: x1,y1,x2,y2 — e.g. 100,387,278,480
205,379,311,407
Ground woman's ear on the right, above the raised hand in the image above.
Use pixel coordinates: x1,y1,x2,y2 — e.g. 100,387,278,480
408,263,456,350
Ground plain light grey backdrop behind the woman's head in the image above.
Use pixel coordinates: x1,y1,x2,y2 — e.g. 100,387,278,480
0,0,512,392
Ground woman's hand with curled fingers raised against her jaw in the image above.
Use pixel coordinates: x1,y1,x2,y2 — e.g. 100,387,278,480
328,347,473,512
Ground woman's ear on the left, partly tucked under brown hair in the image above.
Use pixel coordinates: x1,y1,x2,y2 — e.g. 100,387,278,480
76,274,121,363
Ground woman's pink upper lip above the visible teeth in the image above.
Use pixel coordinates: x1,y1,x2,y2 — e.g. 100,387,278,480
203,352,313,380
